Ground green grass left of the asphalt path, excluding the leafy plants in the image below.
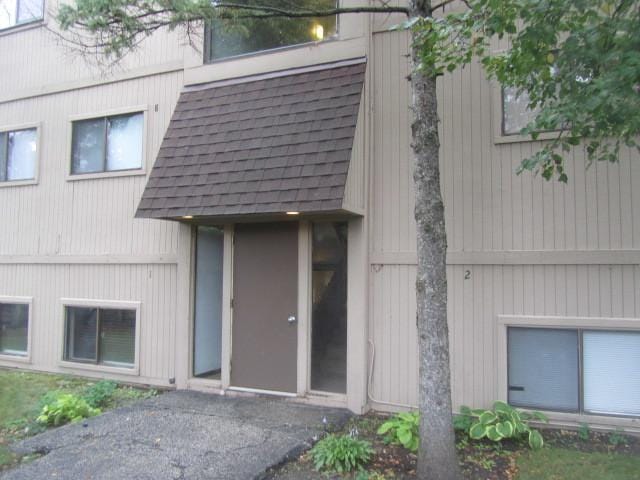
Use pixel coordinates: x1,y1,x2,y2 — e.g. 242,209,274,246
0,368,157,471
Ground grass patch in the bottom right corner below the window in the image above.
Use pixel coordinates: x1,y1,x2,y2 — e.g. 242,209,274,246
517,447,640,480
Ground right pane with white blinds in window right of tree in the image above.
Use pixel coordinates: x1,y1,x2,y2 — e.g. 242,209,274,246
583,331,640,415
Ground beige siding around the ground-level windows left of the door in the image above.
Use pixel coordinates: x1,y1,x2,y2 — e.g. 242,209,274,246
0,264,177,385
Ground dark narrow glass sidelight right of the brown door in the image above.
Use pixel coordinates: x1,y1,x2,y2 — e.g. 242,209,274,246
311,222,348,393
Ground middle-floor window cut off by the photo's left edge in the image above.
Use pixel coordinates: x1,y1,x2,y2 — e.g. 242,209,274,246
0,128,38,183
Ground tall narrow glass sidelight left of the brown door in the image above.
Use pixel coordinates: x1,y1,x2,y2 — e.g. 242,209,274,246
193,226,224,380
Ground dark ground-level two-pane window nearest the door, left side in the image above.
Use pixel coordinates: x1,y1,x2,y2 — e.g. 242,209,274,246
64,305,137,368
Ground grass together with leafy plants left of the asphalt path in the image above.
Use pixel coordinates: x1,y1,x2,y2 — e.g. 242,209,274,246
0,368,157,471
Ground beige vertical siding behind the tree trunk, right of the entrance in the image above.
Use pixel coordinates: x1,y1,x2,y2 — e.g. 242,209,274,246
369,33,640,408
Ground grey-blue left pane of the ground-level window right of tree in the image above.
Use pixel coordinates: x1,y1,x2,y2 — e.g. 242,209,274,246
508,327,579,411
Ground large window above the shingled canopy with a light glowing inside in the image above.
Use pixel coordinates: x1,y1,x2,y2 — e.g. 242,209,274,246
205,0,338,62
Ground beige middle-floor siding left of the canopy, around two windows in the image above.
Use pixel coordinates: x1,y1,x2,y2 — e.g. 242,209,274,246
0,71,182,256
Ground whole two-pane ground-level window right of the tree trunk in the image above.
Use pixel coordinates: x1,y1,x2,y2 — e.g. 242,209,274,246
507,327,640,416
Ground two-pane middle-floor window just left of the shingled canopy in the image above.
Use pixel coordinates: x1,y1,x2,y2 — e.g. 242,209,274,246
71,112,144,175
